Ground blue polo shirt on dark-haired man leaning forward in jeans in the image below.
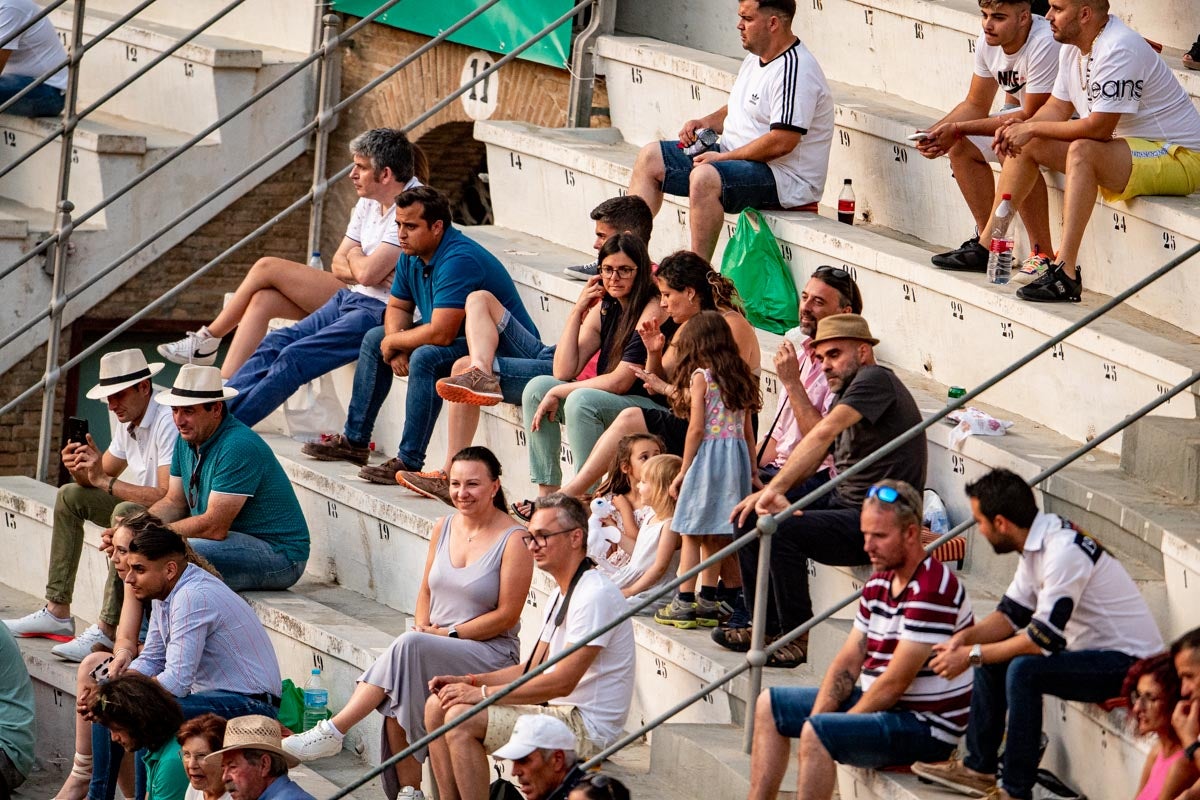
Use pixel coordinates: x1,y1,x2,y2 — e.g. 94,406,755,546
391,225,541,338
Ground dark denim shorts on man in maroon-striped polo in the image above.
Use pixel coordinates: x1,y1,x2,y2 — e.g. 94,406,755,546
769,686,954,769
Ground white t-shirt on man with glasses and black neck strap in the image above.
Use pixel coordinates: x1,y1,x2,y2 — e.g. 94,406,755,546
540,570,635,748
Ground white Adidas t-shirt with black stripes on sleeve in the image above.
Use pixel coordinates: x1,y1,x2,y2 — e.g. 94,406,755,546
721,40,833,207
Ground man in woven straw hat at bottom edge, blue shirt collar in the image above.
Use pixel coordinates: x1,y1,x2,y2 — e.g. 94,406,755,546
208,714,314,800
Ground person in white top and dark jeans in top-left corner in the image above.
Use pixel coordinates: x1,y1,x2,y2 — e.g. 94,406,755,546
0,0,67,116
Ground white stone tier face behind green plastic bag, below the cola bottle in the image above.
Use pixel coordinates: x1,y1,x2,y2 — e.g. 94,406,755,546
475,122,1200,452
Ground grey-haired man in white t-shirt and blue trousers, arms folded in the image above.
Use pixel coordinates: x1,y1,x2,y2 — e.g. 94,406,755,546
212,128,421,427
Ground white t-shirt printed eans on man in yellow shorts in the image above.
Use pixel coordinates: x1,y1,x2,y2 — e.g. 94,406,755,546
1054,14,1200,150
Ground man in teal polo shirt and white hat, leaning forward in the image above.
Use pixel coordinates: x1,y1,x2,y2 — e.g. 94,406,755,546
150,365,308,591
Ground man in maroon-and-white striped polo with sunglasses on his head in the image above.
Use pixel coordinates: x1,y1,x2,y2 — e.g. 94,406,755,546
749,480,974,799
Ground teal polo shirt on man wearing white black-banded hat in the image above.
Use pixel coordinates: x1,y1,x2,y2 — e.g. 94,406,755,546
170,413,308,561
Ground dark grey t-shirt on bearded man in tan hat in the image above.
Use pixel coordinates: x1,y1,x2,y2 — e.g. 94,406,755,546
830,365,928,507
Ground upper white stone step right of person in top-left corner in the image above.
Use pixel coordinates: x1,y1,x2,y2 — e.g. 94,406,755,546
50,4,286,142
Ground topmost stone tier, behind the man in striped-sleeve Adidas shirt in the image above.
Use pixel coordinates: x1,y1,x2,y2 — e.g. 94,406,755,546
617,0,1200,113
